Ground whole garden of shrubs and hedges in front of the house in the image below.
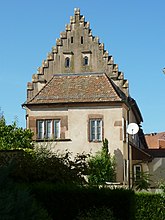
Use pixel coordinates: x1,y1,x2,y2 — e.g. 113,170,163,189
0,116,165,220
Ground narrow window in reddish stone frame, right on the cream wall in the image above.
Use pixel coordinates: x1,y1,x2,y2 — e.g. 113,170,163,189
90,119,102,141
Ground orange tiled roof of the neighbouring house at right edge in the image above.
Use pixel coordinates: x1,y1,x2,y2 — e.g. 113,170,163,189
145,132,165,149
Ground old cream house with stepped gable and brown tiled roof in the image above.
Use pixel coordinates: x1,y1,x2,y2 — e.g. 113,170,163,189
23,9,150,185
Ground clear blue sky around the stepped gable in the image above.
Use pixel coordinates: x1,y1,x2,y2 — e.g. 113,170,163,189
0,0,165,133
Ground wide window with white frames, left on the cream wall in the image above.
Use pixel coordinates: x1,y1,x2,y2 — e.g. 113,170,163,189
37,119,60,139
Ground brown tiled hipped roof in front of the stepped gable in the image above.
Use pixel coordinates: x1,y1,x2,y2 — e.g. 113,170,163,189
27,73,122,104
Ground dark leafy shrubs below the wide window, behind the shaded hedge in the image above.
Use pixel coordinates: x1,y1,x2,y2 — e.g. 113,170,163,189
0,147,86,184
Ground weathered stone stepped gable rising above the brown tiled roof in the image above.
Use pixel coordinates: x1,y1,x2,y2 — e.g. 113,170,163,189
27,8,128,100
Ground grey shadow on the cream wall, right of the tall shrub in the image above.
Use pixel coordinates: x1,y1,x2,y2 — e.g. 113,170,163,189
114,149,124,183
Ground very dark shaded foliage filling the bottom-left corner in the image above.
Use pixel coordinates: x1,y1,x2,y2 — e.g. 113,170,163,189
0,164,51,220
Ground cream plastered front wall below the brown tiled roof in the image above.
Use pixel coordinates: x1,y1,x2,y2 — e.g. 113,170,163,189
27,106,126,182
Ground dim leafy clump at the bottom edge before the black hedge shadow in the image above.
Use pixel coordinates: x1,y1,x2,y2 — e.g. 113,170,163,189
75,207,116,220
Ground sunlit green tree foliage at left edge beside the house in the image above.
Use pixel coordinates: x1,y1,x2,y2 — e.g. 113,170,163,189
0,116,33,150
